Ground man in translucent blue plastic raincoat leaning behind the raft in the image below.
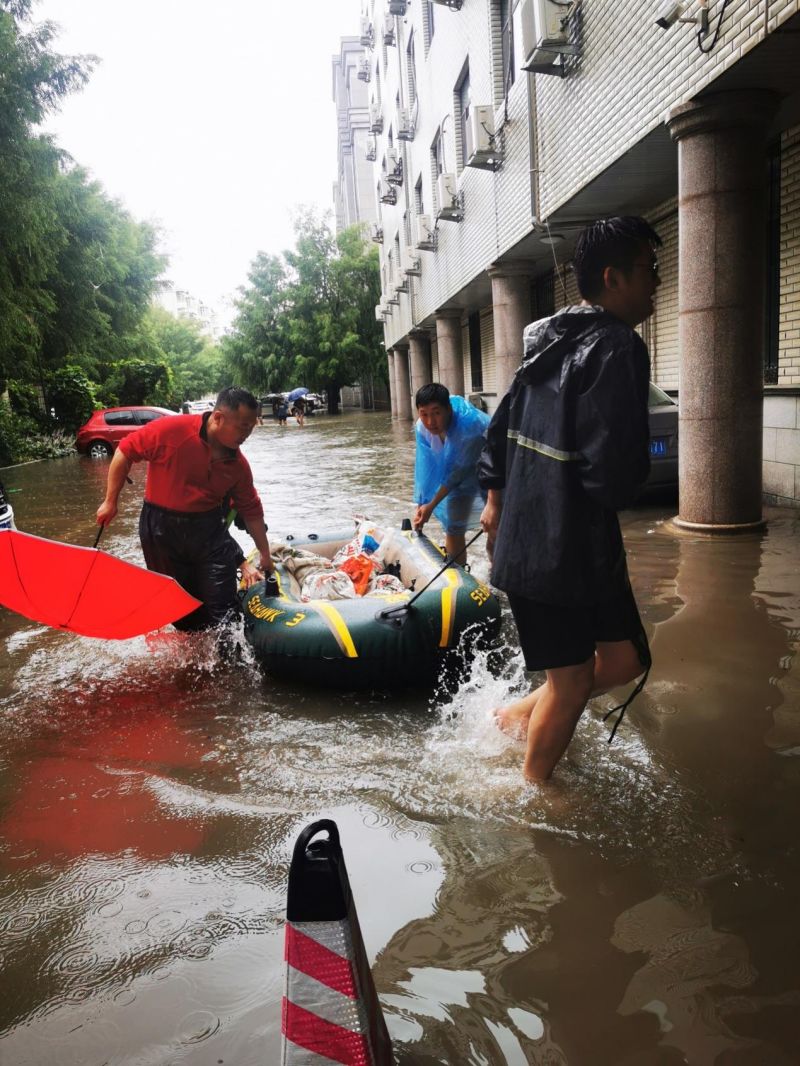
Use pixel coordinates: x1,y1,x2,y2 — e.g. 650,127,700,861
414,383,490,566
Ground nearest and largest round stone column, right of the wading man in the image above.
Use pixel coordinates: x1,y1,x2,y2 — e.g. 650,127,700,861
668,90,778,533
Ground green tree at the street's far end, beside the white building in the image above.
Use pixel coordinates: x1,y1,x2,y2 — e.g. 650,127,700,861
223,208,386,411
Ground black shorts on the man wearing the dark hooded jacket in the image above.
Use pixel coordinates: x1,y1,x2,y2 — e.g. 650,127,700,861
509,585,649,671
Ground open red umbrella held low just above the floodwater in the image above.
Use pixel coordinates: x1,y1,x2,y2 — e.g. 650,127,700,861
0,530,202,641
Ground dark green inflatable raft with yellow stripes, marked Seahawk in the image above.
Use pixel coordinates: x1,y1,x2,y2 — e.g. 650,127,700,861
240,530,500,689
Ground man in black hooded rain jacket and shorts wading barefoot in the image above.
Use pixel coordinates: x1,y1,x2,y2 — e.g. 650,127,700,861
478,217,661,781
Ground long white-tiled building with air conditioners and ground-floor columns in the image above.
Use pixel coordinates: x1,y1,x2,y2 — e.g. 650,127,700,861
361,0,800,532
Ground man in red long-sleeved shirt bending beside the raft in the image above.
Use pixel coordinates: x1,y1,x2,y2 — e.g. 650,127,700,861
97,388,275,630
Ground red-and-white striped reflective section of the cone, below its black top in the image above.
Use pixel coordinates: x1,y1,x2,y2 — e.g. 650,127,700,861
282,904,393,1066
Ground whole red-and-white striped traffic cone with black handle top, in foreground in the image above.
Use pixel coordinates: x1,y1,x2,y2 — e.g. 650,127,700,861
282,819,394,1066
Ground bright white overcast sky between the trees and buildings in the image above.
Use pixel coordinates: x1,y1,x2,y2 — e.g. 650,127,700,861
34,0,361,310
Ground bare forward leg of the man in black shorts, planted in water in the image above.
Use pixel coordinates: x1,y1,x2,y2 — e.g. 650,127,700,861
523,656,595,781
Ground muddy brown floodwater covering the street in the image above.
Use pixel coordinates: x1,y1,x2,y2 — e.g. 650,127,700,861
0,415,800,1066
